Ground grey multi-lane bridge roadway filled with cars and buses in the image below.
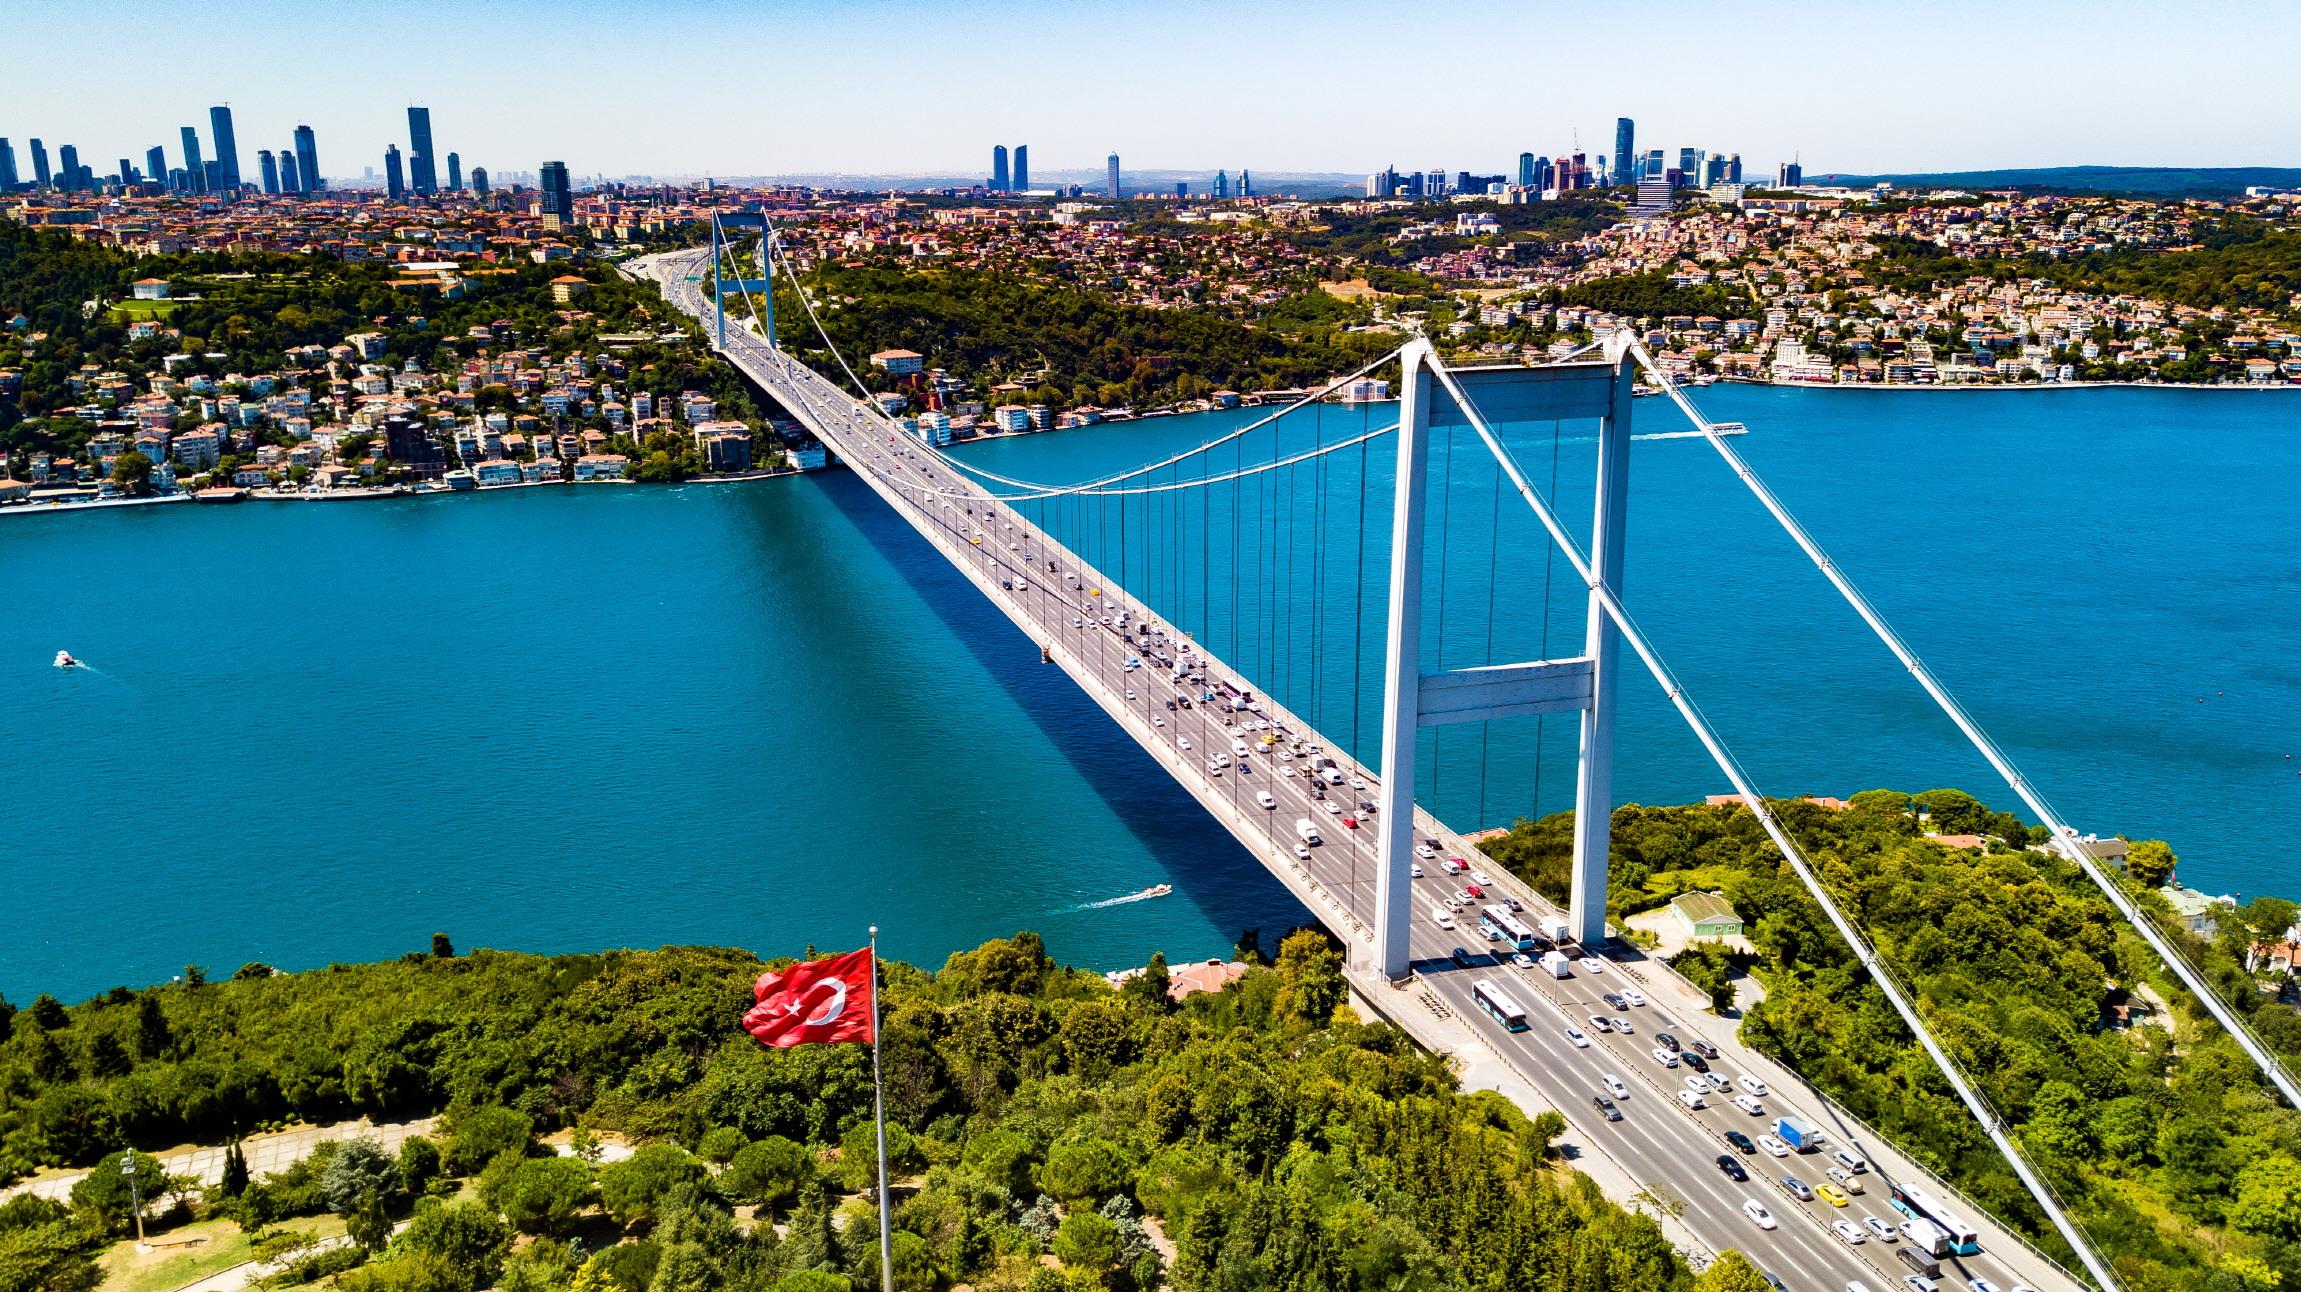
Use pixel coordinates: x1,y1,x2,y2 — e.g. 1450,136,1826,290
630,251,2078,1292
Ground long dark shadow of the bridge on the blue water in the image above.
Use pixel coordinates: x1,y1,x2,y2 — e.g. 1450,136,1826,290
810,470,1316,960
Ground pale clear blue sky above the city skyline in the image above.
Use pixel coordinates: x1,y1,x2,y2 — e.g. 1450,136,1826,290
0,0,2301,175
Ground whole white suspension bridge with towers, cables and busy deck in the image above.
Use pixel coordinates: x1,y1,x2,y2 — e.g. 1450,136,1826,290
628,214,2301,1290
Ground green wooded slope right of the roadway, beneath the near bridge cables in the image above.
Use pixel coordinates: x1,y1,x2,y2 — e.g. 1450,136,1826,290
1486,790,2301,1292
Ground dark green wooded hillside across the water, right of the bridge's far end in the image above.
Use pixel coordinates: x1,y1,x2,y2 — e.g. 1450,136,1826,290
778,267,1397,405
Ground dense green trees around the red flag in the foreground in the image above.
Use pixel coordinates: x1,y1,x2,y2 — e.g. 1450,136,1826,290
0,933,1717,1292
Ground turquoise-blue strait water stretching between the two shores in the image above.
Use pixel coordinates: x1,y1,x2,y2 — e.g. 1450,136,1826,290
0,387,2301,1004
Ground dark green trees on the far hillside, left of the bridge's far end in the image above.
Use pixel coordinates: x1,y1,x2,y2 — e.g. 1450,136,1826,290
0,221,759,454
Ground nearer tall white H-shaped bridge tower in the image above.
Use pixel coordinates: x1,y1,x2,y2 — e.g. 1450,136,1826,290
1374,336,1636,981
